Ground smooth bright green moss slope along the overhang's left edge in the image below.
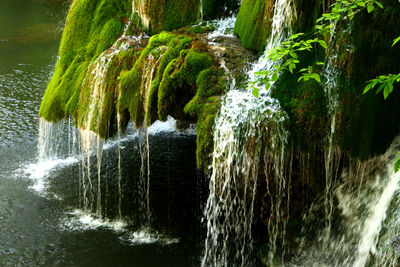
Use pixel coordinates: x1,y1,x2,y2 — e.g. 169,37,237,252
39,0,131,122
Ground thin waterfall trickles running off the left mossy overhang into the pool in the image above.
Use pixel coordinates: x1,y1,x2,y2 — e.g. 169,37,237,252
38,21,152,221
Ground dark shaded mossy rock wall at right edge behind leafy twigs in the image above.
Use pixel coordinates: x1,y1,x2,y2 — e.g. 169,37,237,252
338,0,400,159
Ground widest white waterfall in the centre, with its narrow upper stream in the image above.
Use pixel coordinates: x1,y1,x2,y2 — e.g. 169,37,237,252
202,0,296,266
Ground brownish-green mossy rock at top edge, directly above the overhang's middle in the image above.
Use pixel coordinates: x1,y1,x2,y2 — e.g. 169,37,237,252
132,0,201,34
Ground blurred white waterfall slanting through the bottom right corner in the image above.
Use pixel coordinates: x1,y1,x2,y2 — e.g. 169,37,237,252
293,138,400,267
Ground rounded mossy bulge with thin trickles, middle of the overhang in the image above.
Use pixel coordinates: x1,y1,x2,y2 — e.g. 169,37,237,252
118,32,211,127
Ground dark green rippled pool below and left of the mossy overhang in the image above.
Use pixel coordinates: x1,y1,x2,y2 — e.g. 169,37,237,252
0,0,206,266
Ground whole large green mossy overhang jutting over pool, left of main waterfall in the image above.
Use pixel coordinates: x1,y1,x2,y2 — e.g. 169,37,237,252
39,0,253,170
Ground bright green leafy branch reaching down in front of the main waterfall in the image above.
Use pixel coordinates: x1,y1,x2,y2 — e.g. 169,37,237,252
250,0,382,97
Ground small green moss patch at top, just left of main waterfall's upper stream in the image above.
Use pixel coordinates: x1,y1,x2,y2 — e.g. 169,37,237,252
234,0,274,51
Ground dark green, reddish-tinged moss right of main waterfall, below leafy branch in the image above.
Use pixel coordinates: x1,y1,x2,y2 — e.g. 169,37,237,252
272,41,330,152
